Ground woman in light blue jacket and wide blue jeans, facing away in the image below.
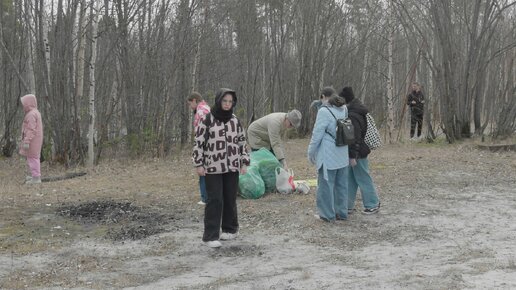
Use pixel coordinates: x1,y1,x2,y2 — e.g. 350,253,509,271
308,87,349,222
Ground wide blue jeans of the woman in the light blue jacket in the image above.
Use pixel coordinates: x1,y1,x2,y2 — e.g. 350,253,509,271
316,166,348,221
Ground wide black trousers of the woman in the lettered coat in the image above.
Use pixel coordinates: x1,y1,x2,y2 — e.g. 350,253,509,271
202,172,238,242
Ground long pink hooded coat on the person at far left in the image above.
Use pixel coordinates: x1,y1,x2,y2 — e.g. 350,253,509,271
19,95,43,158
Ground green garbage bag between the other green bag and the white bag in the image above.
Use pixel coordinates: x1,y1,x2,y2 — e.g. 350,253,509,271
250,148,281,193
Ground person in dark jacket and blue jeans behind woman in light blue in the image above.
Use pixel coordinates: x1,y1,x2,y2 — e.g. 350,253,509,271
339,87,380,214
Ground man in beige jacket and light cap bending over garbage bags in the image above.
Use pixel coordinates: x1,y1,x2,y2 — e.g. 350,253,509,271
247,110,301,169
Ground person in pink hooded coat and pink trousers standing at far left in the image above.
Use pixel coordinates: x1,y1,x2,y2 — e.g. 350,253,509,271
19,95,43,184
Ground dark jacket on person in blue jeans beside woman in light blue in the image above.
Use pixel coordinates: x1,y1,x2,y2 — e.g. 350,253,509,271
346,98,371,159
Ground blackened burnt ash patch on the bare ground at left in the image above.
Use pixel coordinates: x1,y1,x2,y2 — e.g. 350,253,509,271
56,200,174,241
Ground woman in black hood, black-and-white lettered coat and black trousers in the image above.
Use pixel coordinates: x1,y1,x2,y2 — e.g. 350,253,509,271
192,89,250,248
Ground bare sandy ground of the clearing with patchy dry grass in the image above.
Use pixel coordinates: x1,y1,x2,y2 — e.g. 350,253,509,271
0,139,516,289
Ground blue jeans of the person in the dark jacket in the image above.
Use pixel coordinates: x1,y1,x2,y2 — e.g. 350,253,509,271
348,158,379,209
